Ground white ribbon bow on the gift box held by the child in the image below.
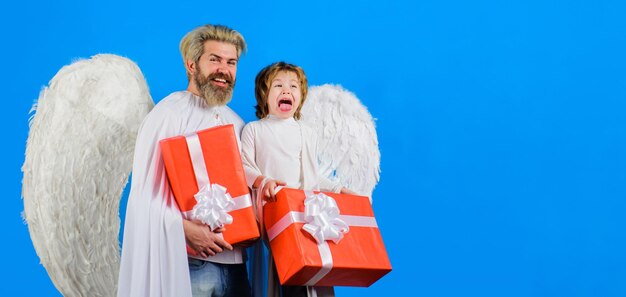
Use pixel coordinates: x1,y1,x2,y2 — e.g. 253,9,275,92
302,193,350,244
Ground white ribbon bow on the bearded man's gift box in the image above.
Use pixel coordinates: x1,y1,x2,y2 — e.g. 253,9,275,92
191,184,235,230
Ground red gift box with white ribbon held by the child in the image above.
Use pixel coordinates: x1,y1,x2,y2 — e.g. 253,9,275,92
263,188,391,287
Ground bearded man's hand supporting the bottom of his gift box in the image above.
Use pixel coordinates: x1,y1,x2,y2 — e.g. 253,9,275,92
183,219,233,258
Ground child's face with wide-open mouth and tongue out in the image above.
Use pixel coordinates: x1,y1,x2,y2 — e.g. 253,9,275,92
267,71,302,119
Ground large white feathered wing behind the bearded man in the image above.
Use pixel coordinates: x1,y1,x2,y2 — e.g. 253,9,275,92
22,55,154,296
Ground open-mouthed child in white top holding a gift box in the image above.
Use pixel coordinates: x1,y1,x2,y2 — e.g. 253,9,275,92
241,62,354,297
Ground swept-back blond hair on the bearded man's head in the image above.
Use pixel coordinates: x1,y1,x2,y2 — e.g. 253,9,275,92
180,24,246,79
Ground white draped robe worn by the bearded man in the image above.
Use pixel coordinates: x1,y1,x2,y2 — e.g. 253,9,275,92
117,91,245,297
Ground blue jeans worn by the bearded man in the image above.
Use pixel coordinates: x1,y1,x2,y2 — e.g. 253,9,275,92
187,258,252,297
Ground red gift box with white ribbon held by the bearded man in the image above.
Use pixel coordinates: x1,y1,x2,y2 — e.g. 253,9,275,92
160,125,259,250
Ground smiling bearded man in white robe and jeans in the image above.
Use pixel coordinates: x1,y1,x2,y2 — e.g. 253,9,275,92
118,25,250,297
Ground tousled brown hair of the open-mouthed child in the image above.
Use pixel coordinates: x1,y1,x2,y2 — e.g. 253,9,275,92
254,61,309,120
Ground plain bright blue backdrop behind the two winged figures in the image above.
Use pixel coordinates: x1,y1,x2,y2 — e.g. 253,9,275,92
0,0,626,296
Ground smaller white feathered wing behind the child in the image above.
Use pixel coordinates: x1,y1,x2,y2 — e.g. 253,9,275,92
302,84,380,199
